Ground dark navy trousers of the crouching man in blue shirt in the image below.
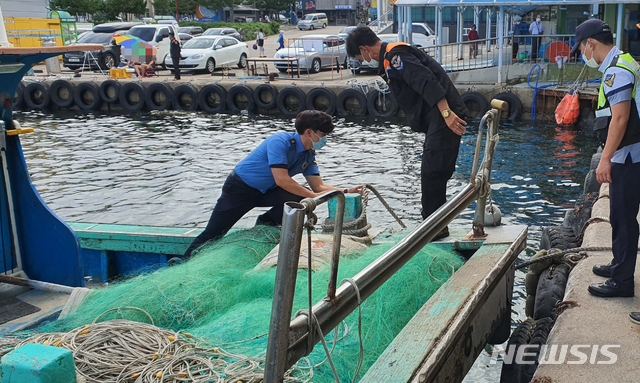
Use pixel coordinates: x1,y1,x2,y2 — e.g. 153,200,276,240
183,172,302,258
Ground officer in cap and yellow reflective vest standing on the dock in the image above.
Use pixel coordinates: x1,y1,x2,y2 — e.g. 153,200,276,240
571,19,640,314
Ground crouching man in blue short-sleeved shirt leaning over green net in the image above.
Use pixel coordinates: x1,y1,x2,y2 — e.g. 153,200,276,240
183,110,362,258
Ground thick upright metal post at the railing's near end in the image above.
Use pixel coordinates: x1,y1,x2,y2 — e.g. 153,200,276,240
264,202,307,383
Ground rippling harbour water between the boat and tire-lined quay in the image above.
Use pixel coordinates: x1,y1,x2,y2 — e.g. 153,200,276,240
17,112,597,382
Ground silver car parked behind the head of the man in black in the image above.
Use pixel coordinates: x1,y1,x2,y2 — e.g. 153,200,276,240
273,35,347,73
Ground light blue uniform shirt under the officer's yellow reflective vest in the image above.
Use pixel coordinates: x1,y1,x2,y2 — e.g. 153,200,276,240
599,46,640,164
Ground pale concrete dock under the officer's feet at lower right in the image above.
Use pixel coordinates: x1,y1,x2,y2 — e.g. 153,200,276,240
533,184,640,383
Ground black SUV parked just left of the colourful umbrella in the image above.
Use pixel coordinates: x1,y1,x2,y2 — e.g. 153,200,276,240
62,22,142,70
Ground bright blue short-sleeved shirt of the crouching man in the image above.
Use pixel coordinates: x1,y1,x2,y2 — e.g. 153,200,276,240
234,132,320,194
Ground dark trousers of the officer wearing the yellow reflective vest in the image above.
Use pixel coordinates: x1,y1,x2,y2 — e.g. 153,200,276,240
609,156,640,287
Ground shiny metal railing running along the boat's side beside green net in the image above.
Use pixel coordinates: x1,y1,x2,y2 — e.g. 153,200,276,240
264,100,507,383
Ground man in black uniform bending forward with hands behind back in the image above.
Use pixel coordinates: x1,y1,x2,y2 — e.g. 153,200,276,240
346,27,467,239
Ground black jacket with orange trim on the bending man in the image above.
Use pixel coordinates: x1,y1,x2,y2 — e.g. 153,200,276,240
378,43,468,133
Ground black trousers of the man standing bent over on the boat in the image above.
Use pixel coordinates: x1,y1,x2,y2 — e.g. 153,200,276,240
421,126,460,219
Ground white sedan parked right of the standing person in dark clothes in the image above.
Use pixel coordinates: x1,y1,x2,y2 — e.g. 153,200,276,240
164,36,249,73
